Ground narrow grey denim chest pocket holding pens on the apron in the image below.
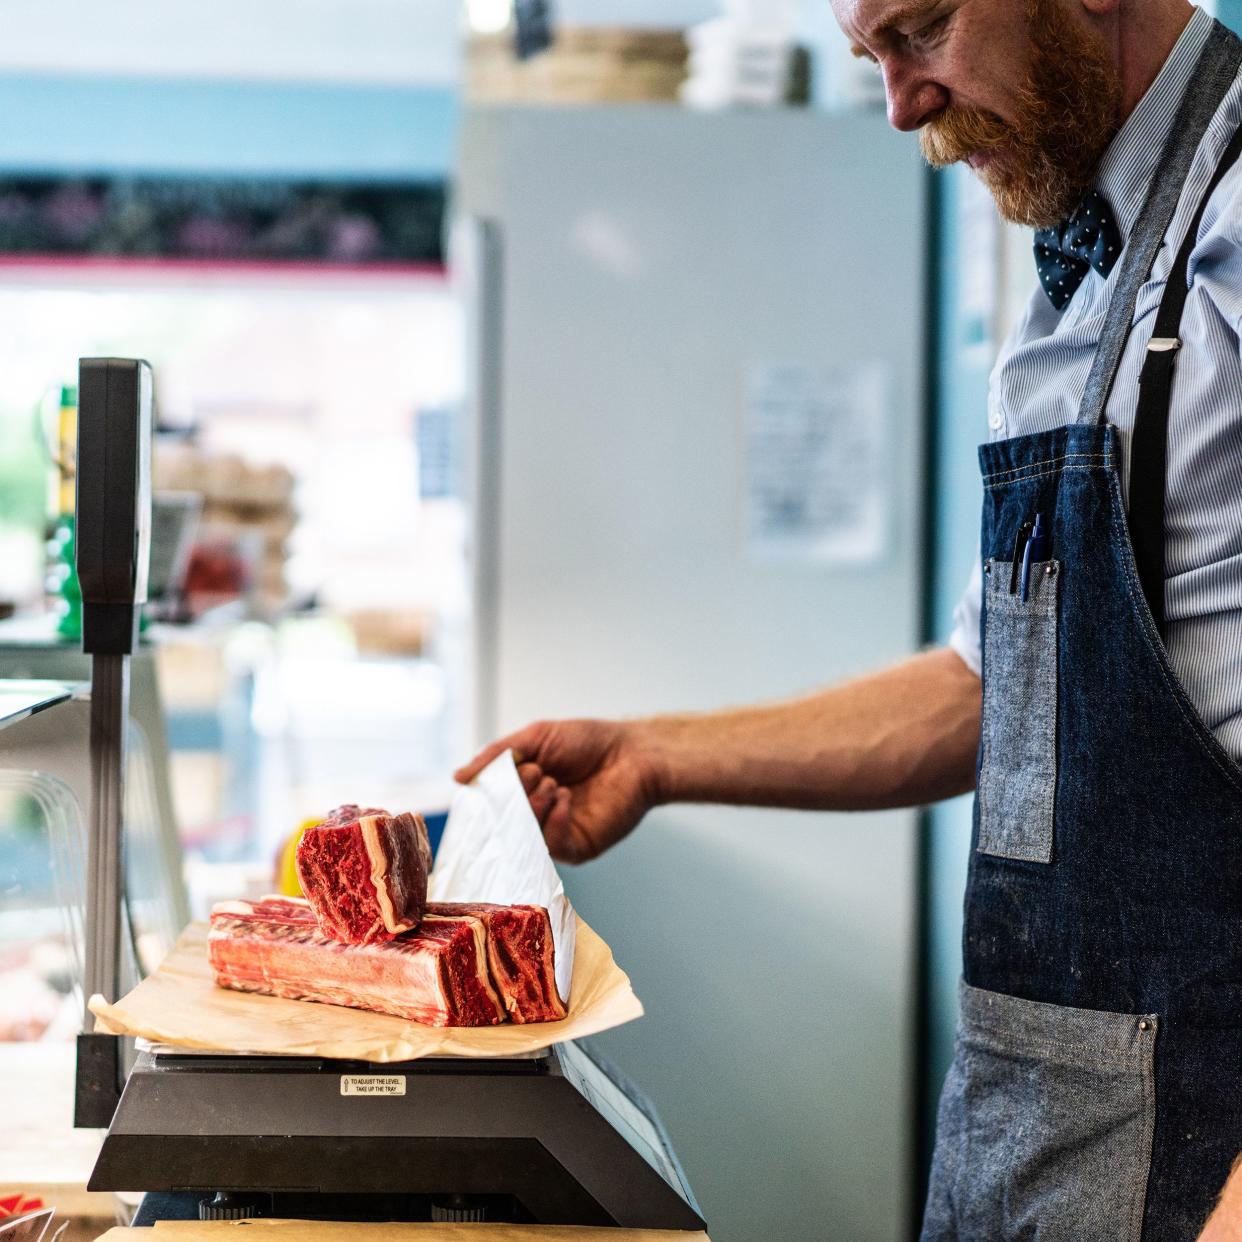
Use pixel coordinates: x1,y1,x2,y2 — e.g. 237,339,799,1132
977,560,1061,862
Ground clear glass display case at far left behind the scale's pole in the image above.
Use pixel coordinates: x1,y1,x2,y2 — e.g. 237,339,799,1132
0,679,185,1223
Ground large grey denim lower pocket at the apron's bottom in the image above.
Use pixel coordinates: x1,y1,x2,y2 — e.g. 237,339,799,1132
923,984,1158,1242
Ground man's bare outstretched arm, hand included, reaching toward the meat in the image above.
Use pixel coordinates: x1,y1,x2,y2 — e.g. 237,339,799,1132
457,651,981,862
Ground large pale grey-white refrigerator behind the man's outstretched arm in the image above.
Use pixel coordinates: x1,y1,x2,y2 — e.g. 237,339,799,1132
455,107,928,1242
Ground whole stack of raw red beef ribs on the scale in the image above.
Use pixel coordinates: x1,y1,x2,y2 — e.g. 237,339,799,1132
207,806,565,1026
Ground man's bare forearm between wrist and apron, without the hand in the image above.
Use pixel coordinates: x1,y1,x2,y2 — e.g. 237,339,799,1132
633,650,981,811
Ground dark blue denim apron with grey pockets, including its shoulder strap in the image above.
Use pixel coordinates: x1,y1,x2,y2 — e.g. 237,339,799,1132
923,26,1242,1242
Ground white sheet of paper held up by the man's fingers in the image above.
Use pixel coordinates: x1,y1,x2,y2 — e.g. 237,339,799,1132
427,750,578,1005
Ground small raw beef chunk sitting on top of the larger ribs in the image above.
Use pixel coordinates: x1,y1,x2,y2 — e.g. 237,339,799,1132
297,805,431,944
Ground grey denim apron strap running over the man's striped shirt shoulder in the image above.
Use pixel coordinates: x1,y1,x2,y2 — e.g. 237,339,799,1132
1078,22,1242,425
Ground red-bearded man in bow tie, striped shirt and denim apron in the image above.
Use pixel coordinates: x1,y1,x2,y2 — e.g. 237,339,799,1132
458,0,1242,1242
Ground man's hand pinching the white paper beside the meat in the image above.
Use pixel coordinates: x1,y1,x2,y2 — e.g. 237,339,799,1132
455,720,657,862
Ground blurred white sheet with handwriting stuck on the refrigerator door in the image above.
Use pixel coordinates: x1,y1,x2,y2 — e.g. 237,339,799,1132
743,363,893,565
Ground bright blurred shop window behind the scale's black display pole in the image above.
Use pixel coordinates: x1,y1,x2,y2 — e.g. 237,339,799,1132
0,274,469,933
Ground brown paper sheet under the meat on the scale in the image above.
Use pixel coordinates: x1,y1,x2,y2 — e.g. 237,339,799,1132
91,919,642,1063
